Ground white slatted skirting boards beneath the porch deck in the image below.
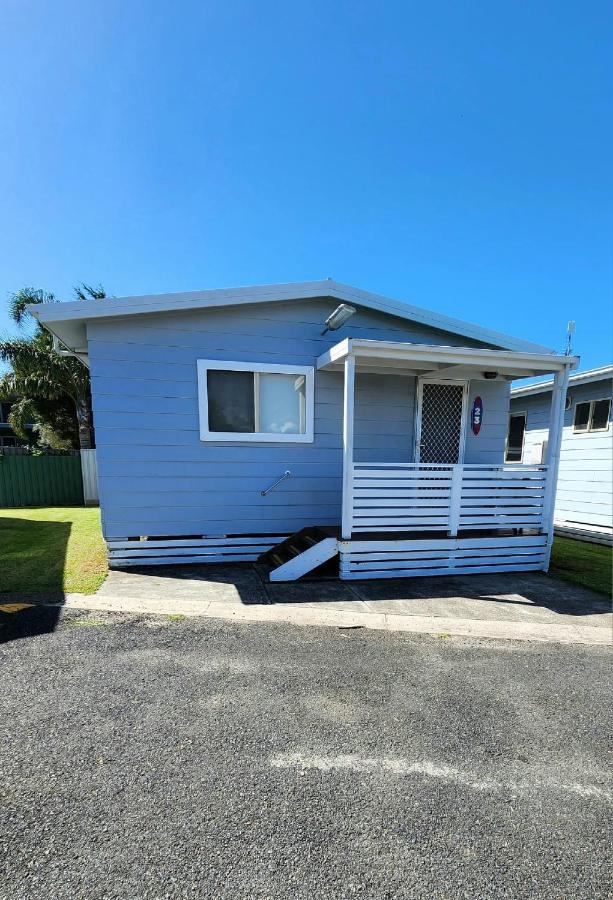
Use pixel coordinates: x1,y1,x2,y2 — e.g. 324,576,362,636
339,534,547,581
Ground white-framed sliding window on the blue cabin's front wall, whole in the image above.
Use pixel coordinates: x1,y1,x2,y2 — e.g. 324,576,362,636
198,359,314,443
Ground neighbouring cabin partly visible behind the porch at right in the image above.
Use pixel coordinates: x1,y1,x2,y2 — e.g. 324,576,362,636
506,366,613,544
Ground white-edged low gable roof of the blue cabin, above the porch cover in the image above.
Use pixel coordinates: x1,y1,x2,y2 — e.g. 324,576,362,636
28,279,553,353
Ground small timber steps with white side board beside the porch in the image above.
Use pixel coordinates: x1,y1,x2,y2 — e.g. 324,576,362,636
258,526,338,581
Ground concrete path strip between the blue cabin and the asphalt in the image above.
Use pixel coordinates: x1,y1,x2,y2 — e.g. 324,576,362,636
55,565,613,644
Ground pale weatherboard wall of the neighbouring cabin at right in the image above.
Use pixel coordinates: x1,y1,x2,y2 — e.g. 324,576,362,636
511,379,613,528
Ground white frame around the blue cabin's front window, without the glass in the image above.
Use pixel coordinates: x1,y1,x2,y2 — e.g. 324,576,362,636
197,359,315,444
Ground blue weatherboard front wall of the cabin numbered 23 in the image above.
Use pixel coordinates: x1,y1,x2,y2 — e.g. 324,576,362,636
87,300,508,539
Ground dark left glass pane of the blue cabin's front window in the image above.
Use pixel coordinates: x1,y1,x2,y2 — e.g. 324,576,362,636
207,369,255,434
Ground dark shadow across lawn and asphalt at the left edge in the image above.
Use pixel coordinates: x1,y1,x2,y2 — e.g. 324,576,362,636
0,517,71,644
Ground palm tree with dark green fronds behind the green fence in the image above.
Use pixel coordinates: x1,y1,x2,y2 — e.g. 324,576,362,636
0,283,106,450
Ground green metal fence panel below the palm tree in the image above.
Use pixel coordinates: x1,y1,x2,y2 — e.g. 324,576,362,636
0,453,83,507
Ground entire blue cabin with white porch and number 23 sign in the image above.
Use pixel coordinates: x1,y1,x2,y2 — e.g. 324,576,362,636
33,281,575,580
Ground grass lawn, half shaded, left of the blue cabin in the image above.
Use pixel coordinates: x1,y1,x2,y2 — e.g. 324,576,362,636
0,506,107,594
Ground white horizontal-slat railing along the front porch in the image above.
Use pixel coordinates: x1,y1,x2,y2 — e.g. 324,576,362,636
351,463,548,535
